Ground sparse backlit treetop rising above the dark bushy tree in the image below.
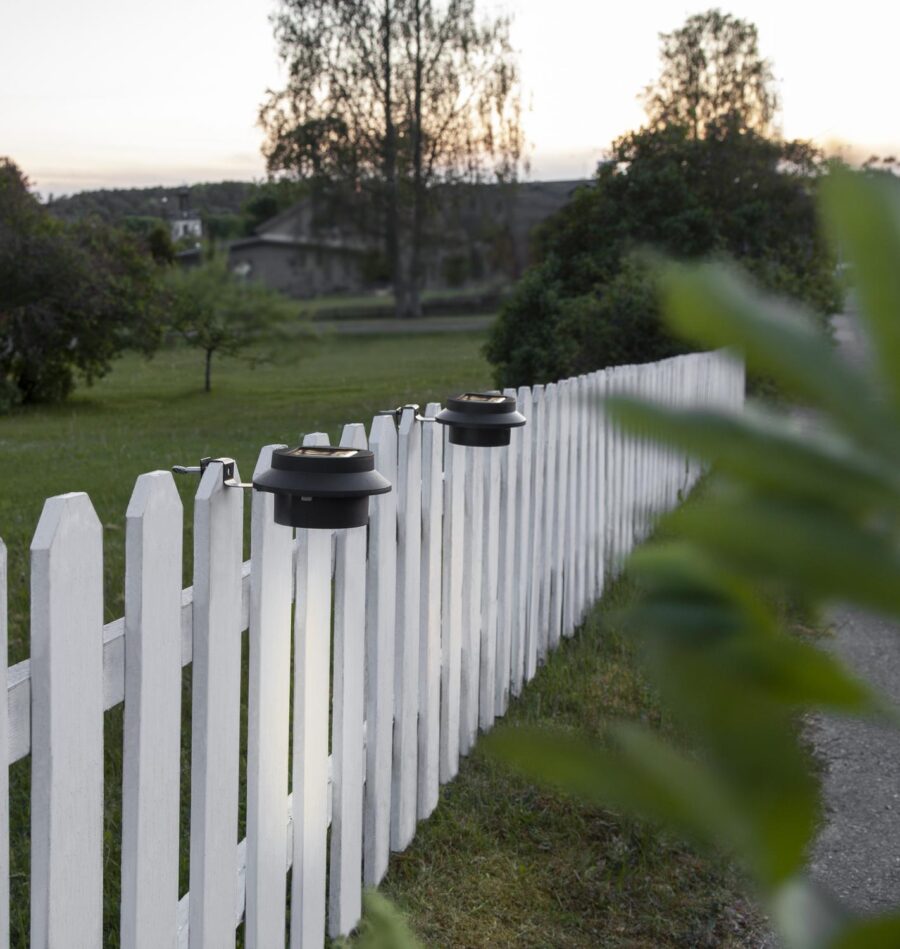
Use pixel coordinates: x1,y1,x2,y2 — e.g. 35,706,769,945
644,10,778,139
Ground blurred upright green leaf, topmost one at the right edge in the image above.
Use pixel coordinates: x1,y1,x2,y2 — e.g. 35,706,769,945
821,171,900,407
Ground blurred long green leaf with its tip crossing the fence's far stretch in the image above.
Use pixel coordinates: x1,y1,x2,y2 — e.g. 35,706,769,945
607,397,900,512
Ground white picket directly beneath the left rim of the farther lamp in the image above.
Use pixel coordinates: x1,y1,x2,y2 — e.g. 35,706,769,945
440,434,466,783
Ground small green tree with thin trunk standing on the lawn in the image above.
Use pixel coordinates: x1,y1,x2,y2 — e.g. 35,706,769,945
167,255,295,392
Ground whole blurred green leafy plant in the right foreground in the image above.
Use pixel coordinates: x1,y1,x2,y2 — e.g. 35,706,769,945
492,167,900,949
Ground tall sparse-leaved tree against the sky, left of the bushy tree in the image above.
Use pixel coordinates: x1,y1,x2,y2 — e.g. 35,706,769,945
260,0,522,316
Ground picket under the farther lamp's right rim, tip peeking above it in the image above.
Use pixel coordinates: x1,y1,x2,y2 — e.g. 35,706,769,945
494,389,522,716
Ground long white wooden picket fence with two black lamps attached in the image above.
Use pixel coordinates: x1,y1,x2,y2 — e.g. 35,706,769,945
0,353,744,949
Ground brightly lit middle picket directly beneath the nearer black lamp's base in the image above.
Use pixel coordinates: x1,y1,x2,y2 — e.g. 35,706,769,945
290,432,333,949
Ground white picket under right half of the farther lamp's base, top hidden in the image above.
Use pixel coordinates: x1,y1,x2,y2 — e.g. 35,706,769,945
474,436,500,731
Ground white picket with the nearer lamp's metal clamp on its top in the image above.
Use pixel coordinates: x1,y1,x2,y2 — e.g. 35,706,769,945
190,461,244,949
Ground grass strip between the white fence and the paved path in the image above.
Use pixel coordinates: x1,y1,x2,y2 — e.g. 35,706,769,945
347,582,763,949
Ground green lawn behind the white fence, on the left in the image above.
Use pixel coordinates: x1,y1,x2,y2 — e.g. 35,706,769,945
0,332,491,662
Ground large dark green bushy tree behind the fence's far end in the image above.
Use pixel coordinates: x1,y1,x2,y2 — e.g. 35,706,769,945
487,14,841,386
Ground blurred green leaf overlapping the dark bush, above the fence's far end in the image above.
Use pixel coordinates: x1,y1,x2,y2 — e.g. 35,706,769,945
662,264,900,457
